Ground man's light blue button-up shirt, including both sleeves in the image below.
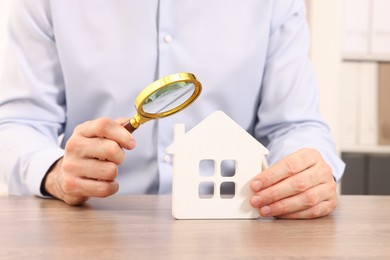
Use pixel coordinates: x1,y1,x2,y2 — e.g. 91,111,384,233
0,0,344,195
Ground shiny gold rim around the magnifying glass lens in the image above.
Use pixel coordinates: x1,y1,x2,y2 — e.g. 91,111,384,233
135,72,202,124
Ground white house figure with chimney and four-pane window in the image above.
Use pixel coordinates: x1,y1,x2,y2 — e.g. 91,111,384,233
167,111,268,219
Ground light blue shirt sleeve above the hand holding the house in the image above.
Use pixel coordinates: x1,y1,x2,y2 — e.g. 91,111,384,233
255,0,345,180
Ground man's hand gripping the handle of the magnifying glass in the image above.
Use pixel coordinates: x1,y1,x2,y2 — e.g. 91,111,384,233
44,118,135,205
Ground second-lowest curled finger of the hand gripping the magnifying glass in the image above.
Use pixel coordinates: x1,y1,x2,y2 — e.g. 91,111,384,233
62,159,118,181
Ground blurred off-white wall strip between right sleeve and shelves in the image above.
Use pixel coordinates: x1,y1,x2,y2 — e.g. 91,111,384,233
305,0,343,148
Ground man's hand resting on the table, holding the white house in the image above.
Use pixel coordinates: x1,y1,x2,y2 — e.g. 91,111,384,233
250,148,337,219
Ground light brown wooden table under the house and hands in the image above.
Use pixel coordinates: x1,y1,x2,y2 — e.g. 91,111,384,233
0,196,390,260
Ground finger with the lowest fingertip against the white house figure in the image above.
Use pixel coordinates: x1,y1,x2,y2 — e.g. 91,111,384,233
254,184,336,217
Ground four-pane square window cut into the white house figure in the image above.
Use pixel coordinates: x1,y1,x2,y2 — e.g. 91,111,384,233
198,159,237,199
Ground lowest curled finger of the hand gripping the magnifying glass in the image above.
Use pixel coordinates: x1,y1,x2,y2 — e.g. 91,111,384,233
63,177,119,198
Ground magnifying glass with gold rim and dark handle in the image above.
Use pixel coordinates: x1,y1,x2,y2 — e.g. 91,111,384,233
123,72,202,133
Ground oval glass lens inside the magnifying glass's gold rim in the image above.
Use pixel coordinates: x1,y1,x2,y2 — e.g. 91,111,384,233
142,82,195,114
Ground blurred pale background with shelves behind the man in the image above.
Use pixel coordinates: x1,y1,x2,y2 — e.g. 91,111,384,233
0,0,390,195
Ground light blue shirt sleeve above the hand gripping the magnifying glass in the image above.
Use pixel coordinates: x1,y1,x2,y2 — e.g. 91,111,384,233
0,0,65,196
